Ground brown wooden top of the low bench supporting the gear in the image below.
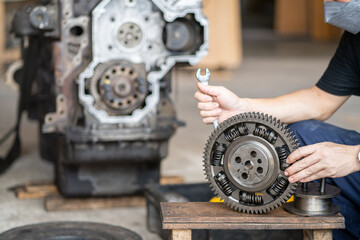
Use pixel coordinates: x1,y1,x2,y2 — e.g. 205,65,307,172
160,202,345,230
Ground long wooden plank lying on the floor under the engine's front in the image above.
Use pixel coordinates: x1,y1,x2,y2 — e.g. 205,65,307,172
45,196,146,211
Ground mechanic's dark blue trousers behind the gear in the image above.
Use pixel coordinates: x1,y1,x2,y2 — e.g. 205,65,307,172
289,120,360,240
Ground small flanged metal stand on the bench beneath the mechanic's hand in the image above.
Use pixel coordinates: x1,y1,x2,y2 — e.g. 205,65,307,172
285,178,340,216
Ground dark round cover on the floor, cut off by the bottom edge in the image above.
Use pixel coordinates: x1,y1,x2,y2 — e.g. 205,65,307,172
0,222,142,240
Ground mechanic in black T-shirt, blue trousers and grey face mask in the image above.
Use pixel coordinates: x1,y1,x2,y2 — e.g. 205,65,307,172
195,0,360,239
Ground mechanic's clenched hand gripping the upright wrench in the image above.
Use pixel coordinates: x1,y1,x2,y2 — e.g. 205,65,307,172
194,83,246,124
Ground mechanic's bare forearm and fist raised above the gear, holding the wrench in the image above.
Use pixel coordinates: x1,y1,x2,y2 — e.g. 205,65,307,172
195,84,350,124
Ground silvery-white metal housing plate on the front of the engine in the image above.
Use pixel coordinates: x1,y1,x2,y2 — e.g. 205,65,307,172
78,0,208,125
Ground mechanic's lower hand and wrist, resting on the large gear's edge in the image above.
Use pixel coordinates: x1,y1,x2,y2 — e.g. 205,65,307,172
285,142,360,183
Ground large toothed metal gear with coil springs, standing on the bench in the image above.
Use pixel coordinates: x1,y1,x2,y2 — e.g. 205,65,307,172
204,113,298,214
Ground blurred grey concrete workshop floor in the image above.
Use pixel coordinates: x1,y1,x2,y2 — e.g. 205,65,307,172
0,34,360,240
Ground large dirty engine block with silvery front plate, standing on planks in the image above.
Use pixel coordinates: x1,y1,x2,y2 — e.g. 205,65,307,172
9,0,208,196
